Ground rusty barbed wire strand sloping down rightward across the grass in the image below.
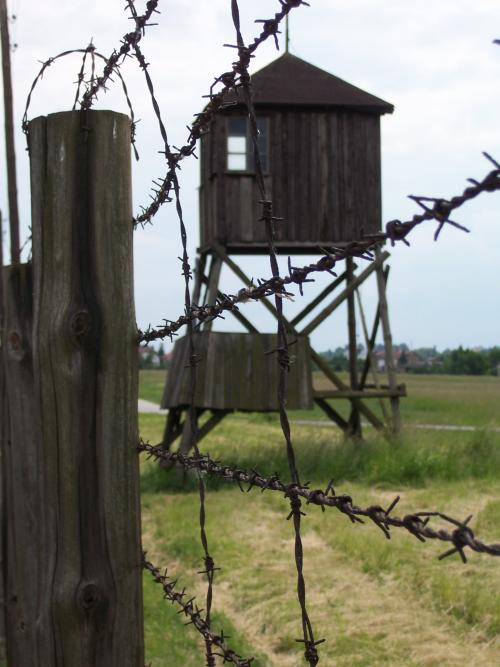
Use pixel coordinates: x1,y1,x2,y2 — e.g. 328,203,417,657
138,440,500,563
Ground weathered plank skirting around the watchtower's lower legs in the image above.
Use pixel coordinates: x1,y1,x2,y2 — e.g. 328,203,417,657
162,332,313,411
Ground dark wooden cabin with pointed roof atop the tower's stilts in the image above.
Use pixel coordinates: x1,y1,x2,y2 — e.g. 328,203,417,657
200,53,393,254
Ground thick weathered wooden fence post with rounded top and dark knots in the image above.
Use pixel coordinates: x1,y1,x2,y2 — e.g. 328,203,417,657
28,111,144,667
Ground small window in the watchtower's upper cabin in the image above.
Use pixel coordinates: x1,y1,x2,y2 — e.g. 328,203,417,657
227,116,269,173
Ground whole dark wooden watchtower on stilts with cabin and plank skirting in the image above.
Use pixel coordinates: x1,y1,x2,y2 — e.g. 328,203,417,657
162,53,404,448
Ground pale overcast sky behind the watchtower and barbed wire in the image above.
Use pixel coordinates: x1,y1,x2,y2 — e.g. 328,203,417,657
0,0,500,350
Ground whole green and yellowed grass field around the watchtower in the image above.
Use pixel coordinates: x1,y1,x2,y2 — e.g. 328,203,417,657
140,373,500,667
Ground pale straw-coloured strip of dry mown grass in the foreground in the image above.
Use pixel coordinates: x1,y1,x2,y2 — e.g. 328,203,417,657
141,496,500,667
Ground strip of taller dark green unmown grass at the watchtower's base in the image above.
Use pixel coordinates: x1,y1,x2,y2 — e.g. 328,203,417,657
142,420,500,493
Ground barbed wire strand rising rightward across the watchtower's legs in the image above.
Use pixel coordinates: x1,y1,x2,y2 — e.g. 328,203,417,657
138,153,500,343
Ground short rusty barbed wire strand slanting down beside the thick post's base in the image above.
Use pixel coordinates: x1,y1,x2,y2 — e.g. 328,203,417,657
142,552,253,667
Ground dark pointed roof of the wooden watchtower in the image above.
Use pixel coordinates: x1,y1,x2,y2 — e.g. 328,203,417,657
225,53,394,114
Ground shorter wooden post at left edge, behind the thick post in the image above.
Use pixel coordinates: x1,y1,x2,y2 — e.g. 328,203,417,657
2,264,39,667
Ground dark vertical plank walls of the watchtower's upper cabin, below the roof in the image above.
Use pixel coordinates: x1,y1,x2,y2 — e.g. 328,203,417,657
200,108,381,253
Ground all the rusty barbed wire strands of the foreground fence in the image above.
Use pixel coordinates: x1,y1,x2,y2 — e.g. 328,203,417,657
18,0,500,667
